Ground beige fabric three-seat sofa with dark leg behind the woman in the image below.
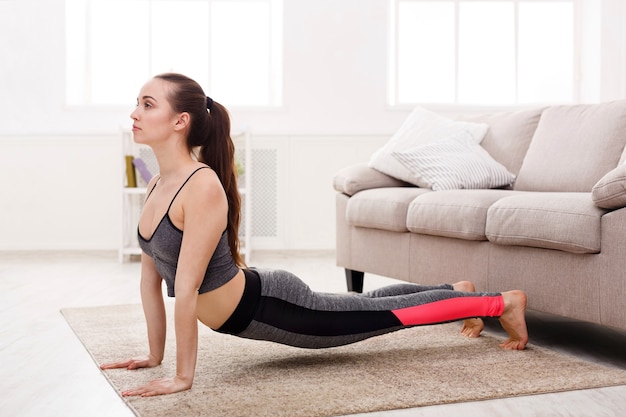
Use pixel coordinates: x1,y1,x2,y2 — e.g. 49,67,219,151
334,101,626,329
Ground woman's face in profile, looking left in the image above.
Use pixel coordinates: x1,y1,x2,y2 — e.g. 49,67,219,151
130,78,178,144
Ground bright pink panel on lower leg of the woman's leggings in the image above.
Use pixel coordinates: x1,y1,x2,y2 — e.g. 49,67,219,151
392,295,504,326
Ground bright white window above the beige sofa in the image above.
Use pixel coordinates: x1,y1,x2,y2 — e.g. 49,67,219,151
388,0,575,106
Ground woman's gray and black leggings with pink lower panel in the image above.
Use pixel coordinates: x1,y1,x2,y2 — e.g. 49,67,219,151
217,269,504,349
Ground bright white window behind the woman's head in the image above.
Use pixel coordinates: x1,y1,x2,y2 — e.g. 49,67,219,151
65,0,282,106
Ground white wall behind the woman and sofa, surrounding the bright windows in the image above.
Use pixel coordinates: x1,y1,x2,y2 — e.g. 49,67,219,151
0,0,626,250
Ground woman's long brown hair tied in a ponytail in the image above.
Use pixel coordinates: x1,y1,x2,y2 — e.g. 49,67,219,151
154,73,245,266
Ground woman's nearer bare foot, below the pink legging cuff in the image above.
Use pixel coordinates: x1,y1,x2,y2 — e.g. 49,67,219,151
500,290,528,350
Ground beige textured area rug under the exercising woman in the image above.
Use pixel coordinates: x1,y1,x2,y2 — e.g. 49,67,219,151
62,305,626,417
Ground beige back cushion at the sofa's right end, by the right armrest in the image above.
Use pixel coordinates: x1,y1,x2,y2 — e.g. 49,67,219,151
515,100,626,192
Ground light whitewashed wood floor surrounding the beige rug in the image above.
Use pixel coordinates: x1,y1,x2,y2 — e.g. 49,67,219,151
0,252,626,417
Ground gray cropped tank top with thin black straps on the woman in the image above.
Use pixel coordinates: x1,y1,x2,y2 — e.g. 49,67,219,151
137,166,239,297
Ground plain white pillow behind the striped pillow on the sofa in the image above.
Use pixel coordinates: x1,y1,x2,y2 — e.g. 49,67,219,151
369,107,489,183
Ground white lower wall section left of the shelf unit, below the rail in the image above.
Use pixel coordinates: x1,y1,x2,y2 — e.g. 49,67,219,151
0,136,122,250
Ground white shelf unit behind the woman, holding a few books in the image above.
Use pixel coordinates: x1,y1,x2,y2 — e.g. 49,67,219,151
118,127,252,263
